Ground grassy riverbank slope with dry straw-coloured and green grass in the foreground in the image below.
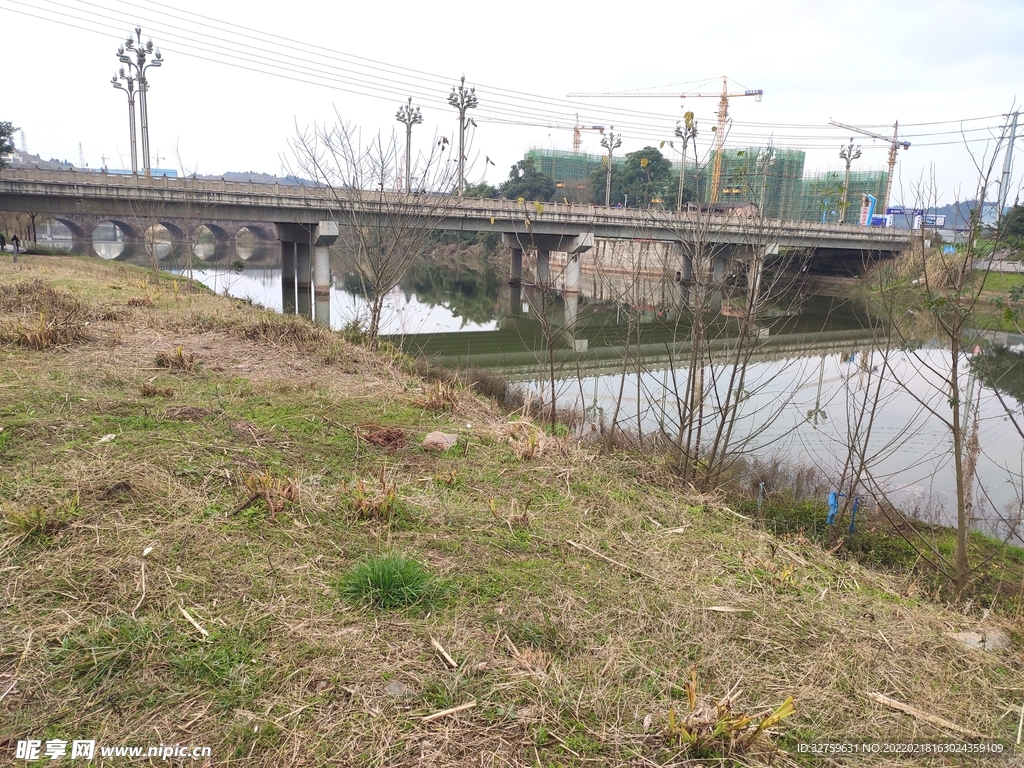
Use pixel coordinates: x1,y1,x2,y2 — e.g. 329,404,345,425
0,257,1024,766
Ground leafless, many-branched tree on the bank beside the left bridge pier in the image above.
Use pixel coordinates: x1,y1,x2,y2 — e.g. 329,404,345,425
292,117,458,347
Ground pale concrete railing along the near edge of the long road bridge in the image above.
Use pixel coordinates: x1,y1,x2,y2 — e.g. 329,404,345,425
0,168,908,243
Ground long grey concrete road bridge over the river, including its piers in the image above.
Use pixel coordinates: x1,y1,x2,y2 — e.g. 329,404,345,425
0,169,909,323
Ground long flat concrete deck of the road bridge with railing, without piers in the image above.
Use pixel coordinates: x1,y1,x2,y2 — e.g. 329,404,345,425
0,169,908,252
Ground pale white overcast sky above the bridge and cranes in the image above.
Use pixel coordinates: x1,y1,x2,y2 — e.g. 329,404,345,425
0,0,1024,204
